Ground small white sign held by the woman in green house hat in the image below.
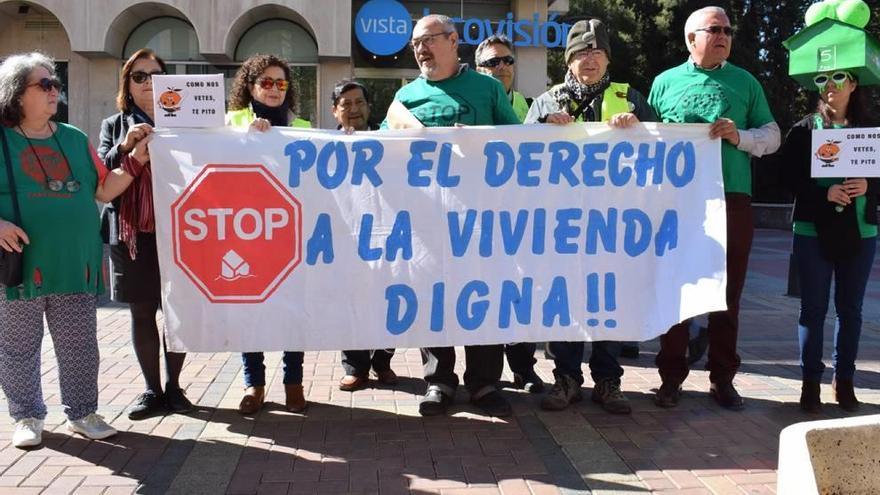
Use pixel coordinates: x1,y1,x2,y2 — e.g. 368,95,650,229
811,127,880,178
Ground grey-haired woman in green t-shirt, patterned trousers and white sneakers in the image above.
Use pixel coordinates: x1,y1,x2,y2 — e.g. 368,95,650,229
0,52,146,447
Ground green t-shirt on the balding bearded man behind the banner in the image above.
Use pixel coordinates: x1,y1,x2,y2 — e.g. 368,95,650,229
382,68,522,129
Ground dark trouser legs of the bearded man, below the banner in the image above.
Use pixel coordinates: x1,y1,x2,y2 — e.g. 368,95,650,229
422,344,504,397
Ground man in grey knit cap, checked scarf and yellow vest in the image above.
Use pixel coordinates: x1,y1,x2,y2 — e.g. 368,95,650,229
525,19,655,414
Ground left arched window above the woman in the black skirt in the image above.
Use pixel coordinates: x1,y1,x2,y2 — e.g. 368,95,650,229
122,17,204,63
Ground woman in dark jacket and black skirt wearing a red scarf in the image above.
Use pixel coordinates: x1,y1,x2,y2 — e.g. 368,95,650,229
98,48,193,420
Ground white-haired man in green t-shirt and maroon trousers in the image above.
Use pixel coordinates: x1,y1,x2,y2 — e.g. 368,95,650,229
648,7,780,409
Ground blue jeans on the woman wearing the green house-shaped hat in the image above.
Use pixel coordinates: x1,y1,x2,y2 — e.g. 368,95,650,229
793,234,877,381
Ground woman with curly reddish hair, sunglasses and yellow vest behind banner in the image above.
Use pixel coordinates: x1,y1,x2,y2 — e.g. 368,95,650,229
226,55,311,414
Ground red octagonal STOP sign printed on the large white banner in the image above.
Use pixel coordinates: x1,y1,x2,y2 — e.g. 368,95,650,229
171,165,302,303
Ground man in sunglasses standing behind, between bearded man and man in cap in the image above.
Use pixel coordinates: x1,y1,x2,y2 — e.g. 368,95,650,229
474,34,544,394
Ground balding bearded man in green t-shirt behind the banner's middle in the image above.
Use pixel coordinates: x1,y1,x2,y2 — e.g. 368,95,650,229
382,15,520,416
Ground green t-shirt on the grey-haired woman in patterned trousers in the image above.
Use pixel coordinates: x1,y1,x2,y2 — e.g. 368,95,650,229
0,124,107,299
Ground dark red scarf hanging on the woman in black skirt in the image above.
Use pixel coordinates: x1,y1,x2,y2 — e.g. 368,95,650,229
119,105,156,260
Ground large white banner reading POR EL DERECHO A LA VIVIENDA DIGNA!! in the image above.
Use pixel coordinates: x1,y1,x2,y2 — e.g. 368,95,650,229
150,124,727,351
